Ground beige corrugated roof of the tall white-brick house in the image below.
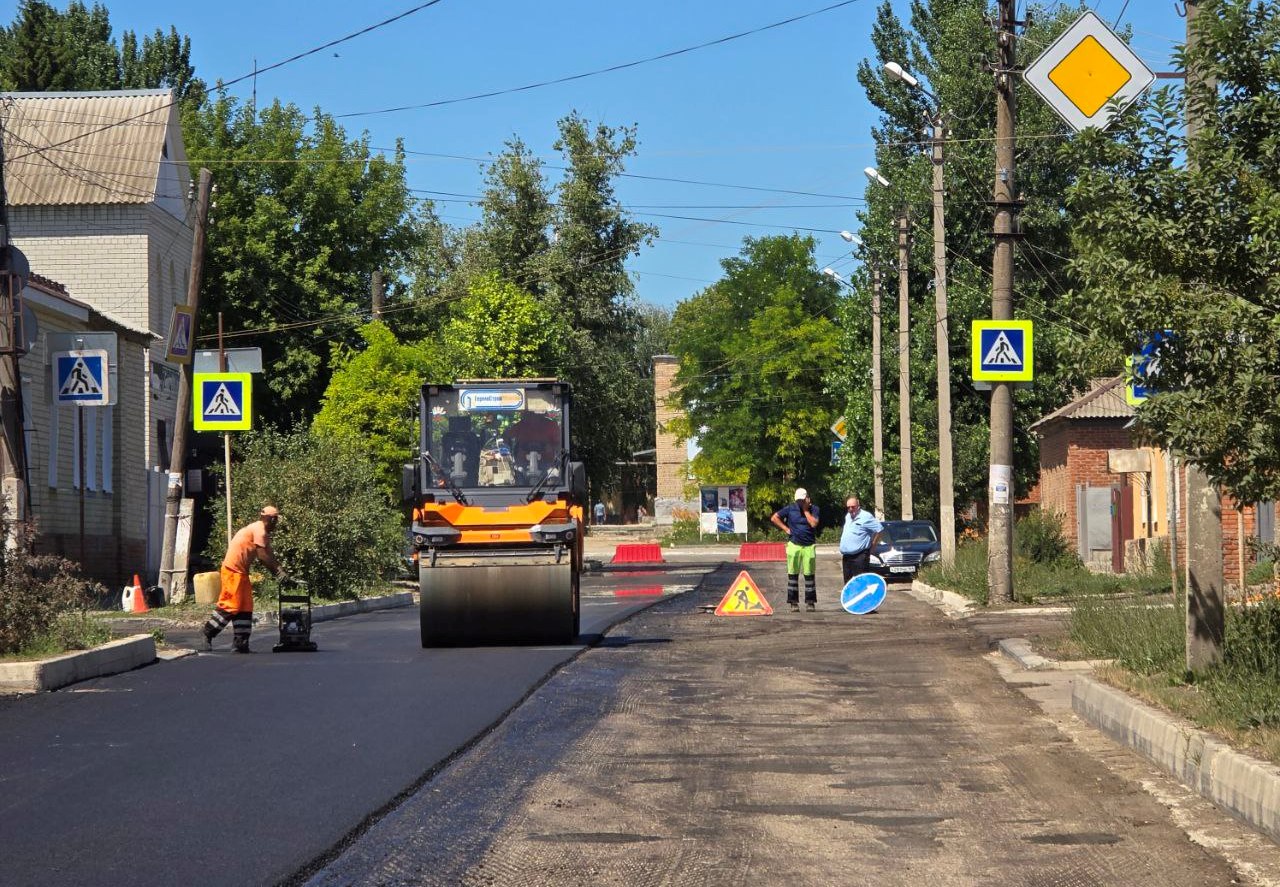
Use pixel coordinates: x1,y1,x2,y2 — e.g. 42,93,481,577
0,90,187,206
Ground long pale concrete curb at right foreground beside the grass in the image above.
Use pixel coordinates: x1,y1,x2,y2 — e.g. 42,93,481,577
1071,675,1280,841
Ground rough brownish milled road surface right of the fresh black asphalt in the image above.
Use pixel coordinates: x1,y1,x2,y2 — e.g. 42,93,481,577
308,559,1280,887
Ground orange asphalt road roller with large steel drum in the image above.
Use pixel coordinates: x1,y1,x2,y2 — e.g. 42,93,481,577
403,379,586,646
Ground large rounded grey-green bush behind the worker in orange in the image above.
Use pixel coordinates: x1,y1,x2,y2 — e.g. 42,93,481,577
209,429,404,599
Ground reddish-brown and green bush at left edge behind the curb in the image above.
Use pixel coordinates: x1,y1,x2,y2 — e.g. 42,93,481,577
0,509,105,655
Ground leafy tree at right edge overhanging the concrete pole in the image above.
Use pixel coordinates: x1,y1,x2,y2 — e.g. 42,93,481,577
1070,0,1280,502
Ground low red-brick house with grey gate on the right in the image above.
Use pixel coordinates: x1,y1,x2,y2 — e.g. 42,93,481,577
1029,376,1276,585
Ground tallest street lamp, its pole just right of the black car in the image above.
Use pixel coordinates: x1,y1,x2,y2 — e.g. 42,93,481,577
884,61,956,564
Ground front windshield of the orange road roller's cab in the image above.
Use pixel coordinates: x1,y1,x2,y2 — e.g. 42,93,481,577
428,387,563,488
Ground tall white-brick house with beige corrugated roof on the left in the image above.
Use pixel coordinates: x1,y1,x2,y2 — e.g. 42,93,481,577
0,90,192,582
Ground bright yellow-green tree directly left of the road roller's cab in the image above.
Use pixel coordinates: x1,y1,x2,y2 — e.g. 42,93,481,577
311,321,449,500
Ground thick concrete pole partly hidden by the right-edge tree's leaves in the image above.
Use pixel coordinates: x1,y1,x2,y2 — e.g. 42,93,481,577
1185,0,1223,672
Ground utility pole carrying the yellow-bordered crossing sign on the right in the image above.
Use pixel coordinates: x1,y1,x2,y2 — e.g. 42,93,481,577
987,0,1018,604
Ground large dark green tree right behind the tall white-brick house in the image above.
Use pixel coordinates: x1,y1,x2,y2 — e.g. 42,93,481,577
184,93,422,419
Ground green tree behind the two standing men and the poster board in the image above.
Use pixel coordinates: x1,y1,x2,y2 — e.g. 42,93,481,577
671,234,838,518
